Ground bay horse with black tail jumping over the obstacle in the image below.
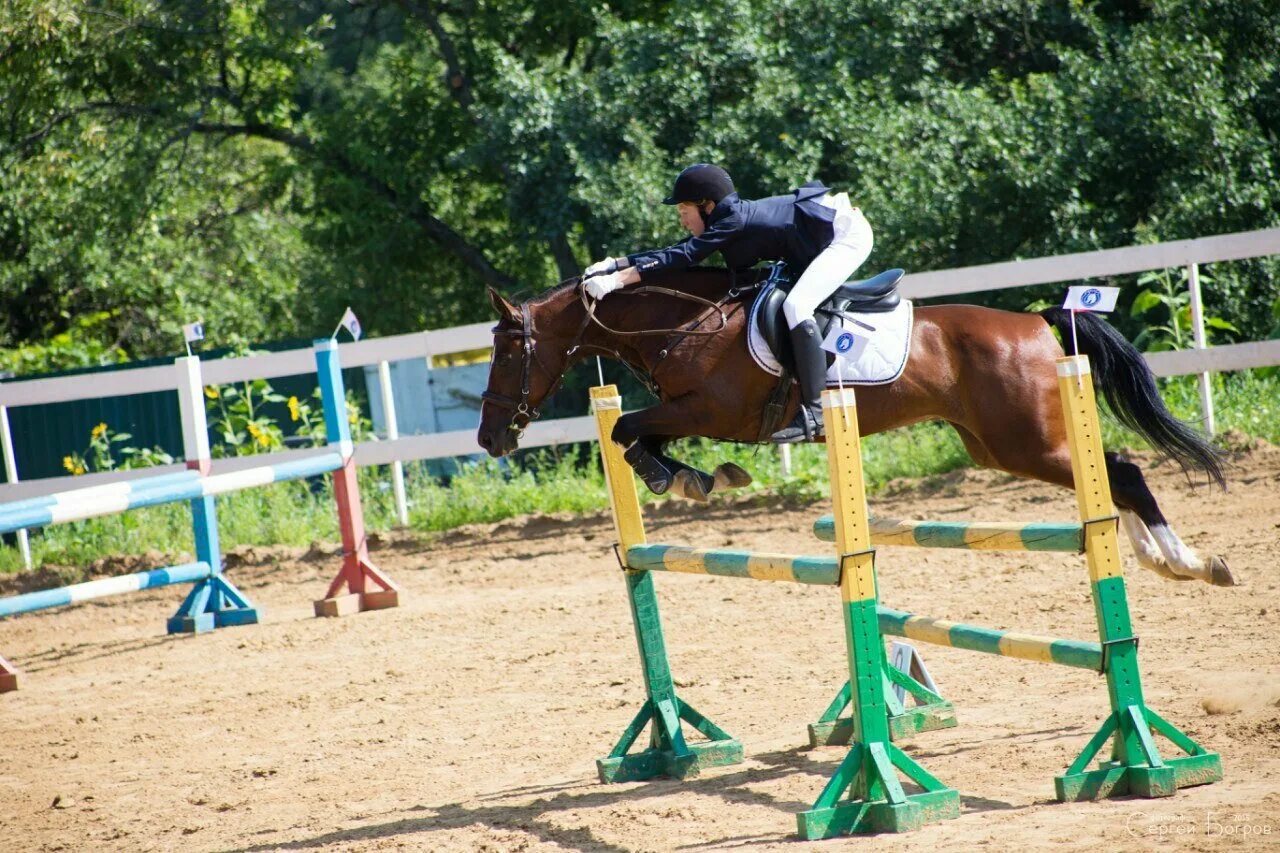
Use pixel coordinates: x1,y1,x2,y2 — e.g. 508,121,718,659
476,268,1235,587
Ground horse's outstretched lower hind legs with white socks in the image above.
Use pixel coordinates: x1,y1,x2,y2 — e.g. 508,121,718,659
1105,453,1235,587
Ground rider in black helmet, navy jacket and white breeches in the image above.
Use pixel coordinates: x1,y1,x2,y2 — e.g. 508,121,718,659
586,163,872,443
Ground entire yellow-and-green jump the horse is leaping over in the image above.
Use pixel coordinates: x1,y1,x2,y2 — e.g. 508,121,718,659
591,356,1222,839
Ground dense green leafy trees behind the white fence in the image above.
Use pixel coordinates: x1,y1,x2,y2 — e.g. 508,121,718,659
0,0,1280,366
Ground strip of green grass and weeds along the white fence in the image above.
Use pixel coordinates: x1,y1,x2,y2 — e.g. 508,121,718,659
0,370,1280,573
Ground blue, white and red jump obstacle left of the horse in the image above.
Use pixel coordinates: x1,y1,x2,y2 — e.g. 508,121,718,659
0,338,399,692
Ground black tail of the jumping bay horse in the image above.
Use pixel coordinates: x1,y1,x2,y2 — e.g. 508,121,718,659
1039,307,1226,488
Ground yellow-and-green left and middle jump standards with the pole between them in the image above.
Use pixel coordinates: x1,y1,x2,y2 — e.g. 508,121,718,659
591,386,960,839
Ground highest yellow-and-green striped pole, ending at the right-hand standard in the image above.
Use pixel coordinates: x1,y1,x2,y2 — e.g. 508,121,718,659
813,515,1084,553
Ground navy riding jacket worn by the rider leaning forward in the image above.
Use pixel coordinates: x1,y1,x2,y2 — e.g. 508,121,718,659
627,181,836,280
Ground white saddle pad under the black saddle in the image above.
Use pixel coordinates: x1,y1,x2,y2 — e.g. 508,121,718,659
746,286,911,386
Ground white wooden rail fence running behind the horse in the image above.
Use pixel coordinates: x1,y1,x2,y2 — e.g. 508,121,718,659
0,228,1280,512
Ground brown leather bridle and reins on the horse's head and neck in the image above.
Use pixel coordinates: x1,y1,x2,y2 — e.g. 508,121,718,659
480,277,759,439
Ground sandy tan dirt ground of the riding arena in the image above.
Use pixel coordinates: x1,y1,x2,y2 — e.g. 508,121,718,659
0,440,1280,850
